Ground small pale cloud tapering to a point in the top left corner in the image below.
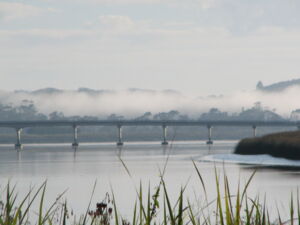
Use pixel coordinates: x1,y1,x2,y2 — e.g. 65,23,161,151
0,2,55,21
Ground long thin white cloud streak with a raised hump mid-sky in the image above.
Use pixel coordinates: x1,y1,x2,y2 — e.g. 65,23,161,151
0,15,198,40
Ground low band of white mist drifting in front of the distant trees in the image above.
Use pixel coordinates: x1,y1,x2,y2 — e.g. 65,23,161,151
0,87,300,119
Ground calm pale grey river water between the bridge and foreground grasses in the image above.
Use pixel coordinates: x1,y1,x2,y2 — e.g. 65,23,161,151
0,141,300,216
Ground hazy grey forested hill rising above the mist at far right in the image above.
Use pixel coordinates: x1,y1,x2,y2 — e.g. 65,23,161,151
256,79,300,92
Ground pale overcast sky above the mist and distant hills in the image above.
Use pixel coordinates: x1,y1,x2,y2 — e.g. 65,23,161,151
0,0,300,95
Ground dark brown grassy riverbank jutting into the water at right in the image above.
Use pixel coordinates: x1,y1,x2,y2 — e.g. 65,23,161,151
234,131,300,160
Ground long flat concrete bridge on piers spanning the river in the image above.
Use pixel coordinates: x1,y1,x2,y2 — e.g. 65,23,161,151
0,120,300,149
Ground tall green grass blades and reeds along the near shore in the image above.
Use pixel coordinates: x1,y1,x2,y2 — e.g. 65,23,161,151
0,162,300,225
